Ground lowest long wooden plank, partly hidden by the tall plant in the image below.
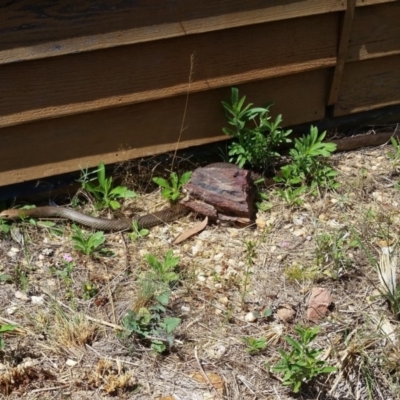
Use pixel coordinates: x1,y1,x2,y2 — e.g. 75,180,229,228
0,69,332,186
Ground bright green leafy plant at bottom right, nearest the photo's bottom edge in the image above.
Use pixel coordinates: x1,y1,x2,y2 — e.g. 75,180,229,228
272,325,336,393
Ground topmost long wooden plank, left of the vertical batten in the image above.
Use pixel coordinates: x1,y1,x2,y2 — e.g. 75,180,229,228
0,0,346,64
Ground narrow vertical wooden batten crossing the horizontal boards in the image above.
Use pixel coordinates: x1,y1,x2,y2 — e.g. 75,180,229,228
328,0,356,105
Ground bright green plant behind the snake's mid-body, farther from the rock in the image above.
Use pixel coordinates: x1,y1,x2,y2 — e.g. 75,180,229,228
78,163,137,210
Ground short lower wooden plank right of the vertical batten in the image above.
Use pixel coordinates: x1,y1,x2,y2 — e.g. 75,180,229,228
334,56,400,116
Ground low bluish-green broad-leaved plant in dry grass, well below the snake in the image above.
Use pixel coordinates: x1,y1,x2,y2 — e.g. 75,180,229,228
122,293,181,353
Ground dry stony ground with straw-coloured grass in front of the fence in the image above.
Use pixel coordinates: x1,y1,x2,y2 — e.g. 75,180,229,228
0,147,400,400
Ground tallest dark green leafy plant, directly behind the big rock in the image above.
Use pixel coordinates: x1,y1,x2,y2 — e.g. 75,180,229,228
222,88,292,168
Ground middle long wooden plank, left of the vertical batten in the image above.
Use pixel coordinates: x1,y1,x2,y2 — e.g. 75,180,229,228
0,14,338,126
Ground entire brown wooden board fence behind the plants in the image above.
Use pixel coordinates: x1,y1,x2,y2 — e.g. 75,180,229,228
0,0,400,185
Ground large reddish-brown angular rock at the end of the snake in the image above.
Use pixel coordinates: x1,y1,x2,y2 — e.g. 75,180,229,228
182,167,256,221
